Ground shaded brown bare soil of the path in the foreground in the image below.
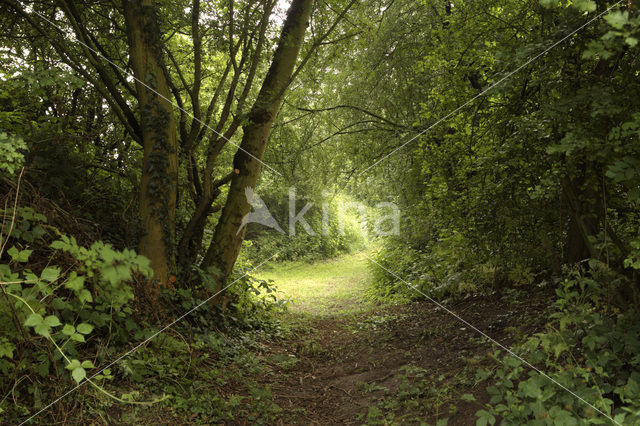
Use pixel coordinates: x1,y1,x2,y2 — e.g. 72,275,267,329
252,289,552,425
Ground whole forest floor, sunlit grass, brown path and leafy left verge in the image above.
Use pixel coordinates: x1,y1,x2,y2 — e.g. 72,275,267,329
107,253,553,425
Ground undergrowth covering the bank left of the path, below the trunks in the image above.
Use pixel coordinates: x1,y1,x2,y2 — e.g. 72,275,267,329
0,182,285,424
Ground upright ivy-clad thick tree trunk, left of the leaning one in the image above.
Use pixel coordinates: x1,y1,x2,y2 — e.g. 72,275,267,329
123,0,178,285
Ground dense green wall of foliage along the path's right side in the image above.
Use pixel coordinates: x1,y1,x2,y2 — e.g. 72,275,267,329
266,0,640,424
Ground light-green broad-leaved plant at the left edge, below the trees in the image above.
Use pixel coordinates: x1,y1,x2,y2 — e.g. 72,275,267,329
0,208,151,413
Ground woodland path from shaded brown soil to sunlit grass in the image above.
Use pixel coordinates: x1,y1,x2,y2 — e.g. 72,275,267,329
254,254,542,425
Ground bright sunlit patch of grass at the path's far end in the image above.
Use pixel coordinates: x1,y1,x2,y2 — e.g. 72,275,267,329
258,253,372,316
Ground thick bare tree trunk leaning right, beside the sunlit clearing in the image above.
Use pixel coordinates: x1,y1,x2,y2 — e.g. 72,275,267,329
202,0,313,289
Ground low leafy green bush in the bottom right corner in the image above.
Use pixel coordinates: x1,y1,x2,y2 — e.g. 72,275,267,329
477,261,640,425
